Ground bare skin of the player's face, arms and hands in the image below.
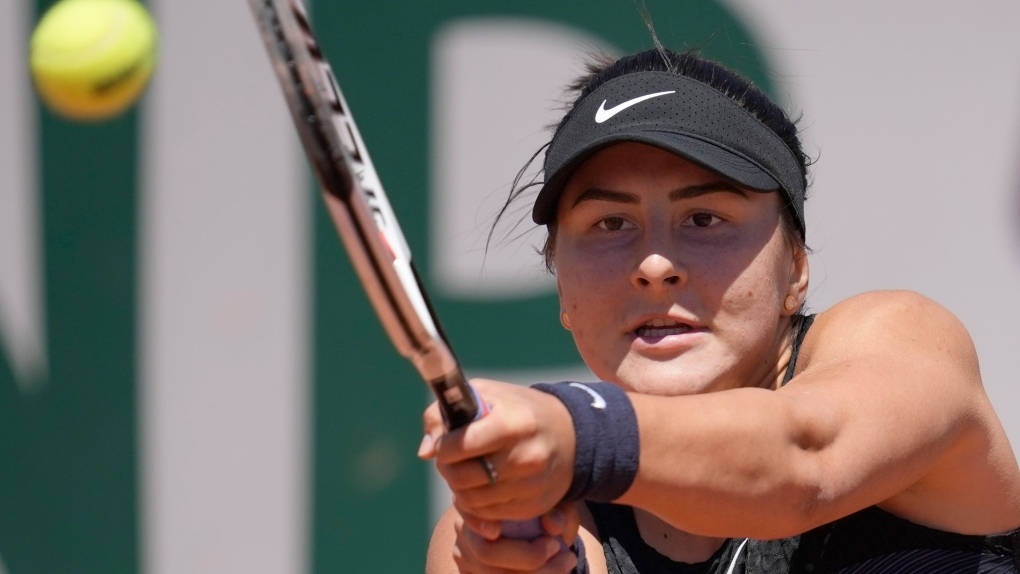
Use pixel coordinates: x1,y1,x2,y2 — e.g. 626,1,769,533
419,143,1020,573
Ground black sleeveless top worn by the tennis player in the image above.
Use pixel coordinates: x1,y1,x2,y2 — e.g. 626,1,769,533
587,315,1020,574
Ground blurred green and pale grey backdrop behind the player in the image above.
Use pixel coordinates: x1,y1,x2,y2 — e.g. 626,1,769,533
0,0,1020,574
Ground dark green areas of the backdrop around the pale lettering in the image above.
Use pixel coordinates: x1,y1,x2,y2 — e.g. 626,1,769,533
0,0,769,574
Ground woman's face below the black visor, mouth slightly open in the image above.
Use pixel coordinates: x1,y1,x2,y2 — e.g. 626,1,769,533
554,143,808,395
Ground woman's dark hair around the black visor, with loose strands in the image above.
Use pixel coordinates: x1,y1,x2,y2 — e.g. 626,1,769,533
487,46,810,271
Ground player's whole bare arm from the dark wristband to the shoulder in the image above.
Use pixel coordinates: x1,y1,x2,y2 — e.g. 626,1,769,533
616,293,1020,538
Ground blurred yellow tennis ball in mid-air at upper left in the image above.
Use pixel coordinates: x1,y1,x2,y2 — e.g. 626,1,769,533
29,0,157,119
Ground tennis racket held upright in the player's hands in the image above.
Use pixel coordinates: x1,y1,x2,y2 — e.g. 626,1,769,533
248,0,542,538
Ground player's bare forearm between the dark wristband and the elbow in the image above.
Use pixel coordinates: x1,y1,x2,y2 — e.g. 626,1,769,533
618,388,824,538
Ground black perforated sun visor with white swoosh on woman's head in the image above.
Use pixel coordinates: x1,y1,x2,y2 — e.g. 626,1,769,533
532,71,805,230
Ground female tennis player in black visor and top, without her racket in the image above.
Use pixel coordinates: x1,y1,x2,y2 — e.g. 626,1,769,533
419,50,1020,574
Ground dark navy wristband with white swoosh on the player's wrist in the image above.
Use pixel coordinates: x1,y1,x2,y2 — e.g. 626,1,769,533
533,382,640,503
